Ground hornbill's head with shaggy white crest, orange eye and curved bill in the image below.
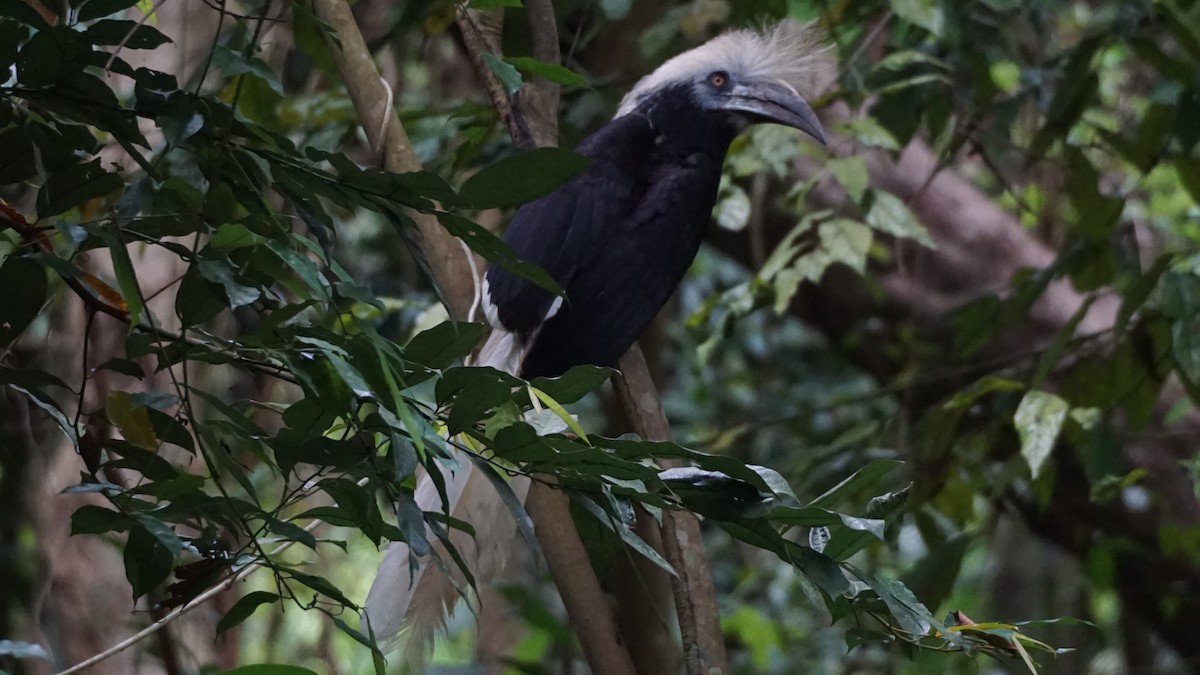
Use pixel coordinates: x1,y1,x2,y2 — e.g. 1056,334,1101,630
617,20,824,143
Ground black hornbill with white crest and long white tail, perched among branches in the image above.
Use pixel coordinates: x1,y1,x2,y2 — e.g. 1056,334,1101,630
366,22,824,650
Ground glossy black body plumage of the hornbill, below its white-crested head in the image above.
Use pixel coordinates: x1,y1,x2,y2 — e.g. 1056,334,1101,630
487,84,739,378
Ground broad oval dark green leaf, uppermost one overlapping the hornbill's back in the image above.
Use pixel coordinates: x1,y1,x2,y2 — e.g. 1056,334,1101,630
458,148,590,209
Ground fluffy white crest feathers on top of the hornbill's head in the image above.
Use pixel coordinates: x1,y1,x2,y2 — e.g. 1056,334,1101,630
617,20,823,118
